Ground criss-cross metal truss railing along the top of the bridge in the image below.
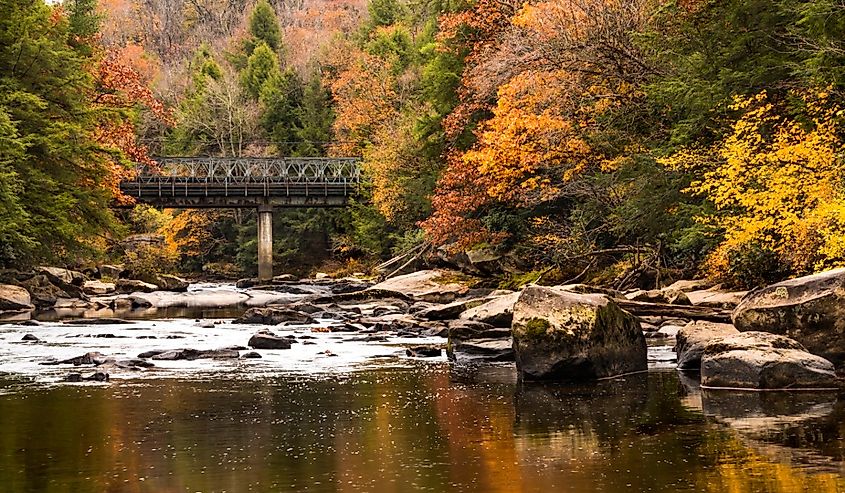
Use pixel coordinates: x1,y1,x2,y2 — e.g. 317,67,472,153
126,157,361,185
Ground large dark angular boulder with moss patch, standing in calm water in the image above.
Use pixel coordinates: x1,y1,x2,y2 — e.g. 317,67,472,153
512,286,647,381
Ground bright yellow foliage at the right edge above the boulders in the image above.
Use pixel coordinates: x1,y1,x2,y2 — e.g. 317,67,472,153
663,91,845,276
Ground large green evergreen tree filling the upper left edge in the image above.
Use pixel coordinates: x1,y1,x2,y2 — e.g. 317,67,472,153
0,0,114,264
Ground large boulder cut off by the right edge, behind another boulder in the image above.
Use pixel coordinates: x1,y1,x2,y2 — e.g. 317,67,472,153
732,269,845,367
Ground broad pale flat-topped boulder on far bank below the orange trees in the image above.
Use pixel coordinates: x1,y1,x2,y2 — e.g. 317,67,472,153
367,270,469,303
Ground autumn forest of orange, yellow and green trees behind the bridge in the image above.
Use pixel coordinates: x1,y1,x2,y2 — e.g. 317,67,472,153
0,0,845,288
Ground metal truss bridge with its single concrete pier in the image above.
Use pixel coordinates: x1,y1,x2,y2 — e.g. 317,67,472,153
120,157,361,280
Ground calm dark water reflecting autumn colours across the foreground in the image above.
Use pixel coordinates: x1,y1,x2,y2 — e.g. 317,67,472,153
0,364,845,493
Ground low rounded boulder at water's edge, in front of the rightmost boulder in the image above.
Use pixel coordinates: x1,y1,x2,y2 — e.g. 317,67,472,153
701,331,839,390
